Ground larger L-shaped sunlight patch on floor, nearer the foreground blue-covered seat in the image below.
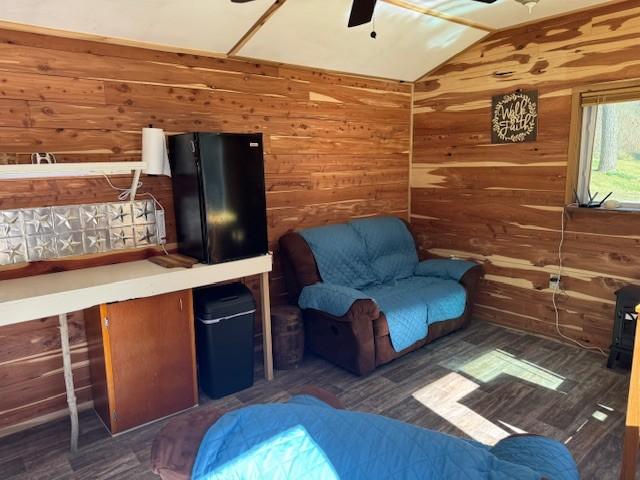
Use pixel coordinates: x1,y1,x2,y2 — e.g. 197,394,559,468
413,372,510,445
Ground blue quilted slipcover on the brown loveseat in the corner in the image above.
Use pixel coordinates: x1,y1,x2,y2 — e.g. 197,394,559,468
298,217,475,352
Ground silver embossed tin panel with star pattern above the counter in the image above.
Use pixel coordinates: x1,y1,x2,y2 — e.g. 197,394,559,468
0,200,164,265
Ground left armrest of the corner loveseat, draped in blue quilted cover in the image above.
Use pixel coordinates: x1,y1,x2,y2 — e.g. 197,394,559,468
298,282,380,321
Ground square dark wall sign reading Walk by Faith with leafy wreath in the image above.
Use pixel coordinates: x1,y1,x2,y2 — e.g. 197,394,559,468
491,90,538,143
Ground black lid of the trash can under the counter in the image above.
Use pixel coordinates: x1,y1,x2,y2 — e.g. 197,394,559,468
193,282,256,320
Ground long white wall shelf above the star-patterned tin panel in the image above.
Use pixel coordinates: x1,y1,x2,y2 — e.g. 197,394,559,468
0,162,147,179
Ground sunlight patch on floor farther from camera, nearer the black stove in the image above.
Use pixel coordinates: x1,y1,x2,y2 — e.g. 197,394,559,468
459,349,565,390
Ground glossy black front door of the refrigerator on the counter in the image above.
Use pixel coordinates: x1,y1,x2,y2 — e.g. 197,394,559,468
198,133,268,263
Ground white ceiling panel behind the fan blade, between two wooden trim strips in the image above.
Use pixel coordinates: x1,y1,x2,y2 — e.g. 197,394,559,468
239,0,486,81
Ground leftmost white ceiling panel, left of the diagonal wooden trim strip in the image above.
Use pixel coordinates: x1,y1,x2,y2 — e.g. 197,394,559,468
0,0,273,53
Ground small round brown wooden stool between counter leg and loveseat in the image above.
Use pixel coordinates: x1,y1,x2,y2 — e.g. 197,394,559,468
271,305,304,370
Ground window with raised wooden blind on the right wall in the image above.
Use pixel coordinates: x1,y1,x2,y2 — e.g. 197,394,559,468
574,88,640,209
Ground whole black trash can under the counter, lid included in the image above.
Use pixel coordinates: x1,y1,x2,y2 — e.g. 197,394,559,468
194,283,256,398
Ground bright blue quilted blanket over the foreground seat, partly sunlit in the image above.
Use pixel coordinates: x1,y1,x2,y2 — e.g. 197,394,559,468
192,396,578,480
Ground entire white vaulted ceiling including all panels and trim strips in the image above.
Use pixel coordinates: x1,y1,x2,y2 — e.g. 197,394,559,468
0,0,615,81
